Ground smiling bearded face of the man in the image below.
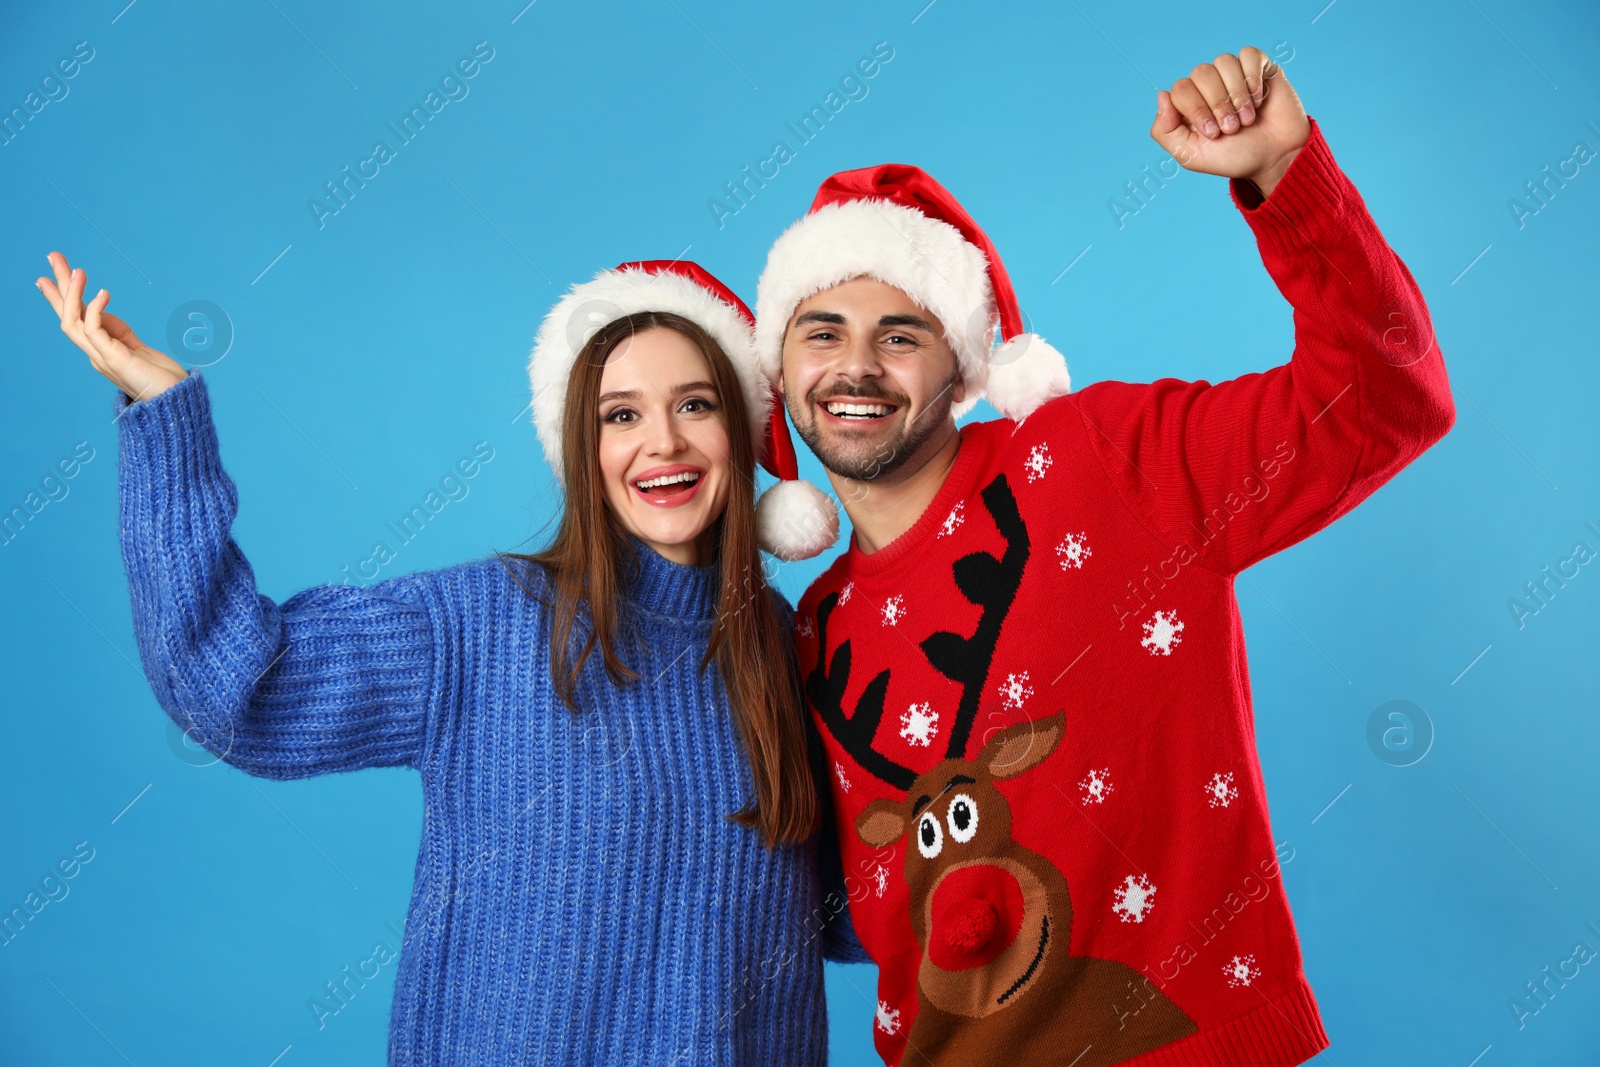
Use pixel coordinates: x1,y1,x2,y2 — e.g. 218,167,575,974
782,278,966,482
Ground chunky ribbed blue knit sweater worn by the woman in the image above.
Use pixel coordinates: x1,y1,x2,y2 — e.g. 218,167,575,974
114,371,866,1065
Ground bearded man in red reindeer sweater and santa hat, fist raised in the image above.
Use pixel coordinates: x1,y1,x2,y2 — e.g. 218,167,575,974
757,48,1454,1067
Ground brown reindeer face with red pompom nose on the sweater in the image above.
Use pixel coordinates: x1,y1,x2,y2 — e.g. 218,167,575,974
856,712,1070,1017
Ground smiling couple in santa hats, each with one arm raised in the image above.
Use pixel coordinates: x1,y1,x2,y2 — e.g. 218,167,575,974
40,48,1454,1067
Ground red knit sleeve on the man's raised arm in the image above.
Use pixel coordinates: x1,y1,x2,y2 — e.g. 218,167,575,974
1077,118,1456,574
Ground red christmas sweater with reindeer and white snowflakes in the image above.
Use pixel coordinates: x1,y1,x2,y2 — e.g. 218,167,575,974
797,120,1454,1067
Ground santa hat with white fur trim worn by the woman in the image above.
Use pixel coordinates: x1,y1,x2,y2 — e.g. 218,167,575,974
528,259,838,560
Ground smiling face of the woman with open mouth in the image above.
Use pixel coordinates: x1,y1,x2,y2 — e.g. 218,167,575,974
600,326,731,566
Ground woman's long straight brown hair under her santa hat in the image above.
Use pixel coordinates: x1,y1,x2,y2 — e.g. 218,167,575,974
496,312,818,846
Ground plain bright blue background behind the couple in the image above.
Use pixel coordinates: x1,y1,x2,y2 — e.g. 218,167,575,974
0,0,1600,1067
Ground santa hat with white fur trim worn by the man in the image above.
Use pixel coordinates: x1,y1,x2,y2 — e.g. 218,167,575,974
755,163,1072,421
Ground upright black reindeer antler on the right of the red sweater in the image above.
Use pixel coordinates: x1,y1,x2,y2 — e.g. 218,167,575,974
922,474,1029,760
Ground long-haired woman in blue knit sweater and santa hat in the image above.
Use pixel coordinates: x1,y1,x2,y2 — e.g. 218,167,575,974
38,254,864,1064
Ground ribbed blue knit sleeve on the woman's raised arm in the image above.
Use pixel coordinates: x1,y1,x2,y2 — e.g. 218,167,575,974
112,371,434,777
